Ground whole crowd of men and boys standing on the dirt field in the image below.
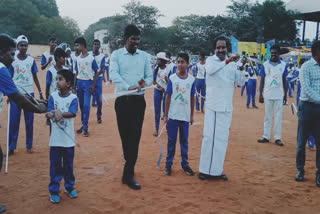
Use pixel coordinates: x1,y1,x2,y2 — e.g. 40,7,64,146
0,25,320,212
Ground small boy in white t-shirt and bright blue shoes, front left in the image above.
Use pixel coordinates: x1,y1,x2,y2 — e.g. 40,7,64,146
46,69,78,203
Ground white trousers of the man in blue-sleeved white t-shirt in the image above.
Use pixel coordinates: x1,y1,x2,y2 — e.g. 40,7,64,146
263,99,283,140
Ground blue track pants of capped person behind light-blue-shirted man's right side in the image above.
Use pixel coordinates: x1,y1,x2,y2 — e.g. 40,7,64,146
153,89,166,131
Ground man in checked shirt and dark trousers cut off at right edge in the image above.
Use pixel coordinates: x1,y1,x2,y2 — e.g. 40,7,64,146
296,41,320,187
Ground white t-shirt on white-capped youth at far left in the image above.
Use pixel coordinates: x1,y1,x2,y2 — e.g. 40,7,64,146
10,55,38,94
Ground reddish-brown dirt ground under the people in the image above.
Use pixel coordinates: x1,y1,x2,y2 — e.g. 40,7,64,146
0,60,320,214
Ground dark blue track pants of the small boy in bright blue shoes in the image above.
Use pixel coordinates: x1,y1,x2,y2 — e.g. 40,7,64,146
49,146,75,195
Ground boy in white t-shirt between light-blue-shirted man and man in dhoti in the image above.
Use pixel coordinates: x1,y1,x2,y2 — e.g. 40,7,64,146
165,53,196,176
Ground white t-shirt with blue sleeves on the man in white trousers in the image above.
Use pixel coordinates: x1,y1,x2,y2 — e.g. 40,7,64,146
261,61,287,100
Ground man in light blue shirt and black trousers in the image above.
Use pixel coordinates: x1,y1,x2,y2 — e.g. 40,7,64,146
110,25,153,190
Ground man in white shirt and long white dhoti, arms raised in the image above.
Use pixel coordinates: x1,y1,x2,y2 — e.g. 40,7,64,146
199,36,246,180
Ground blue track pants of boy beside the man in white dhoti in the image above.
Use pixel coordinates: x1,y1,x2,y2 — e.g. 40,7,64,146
166,119,189,168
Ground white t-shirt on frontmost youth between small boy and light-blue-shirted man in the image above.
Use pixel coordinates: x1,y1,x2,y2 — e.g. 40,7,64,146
75,54,98,80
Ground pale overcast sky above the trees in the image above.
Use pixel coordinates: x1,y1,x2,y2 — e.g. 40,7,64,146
56,0,316,38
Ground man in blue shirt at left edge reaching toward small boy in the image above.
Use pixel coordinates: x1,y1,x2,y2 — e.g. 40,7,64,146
0,34,46,213
